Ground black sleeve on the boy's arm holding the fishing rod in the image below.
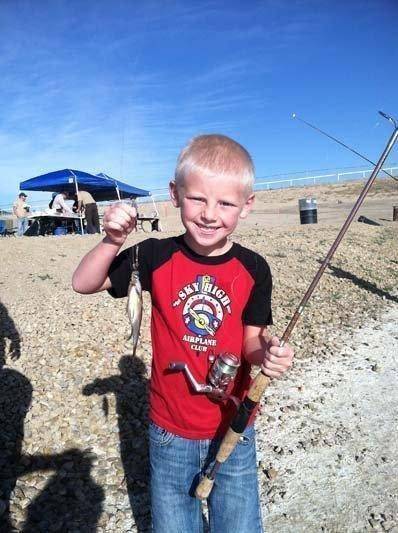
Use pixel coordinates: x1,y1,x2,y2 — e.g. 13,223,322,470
242,254,273,326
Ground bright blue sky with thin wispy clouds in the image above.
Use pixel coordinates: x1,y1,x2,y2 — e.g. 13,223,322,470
0,0,398,205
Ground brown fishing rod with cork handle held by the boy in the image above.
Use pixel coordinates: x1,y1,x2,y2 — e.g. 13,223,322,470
195,113,398,500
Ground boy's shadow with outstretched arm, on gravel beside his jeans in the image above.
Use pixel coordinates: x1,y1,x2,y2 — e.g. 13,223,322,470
83,355,151,533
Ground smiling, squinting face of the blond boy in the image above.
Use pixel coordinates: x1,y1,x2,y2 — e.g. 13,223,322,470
170,169,254,255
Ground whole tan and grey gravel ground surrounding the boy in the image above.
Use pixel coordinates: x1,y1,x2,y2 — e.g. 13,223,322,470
0,182,398,533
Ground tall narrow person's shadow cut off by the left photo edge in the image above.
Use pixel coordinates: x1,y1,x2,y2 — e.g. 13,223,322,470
0,302,32,533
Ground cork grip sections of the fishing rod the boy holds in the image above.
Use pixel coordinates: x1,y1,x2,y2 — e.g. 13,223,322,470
195,371,271,500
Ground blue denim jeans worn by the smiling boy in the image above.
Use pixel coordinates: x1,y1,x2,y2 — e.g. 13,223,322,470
149,422,263,533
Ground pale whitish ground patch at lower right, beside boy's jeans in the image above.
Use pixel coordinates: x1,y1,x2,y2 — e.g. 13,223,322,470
258,304,398,533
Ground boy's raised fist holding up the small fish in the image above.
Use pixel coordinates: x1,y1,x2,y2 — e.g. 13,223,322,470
102,203,137,246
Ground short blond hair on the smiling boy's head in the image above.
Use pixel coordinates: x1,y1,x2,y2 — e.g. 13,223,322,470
174,134,254,193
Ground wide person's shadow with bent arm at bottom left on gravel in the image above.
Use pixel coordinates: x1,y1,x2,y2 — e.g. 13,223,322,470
21,449,104,533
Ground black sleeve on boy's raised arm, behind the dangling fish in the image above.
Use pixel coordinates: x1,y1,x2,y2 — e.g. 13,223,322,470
108,239,156,298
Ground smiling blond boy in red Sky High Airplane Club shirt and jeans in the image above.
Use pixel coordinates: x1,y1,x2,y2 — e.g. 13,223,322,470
73,135,293,533
